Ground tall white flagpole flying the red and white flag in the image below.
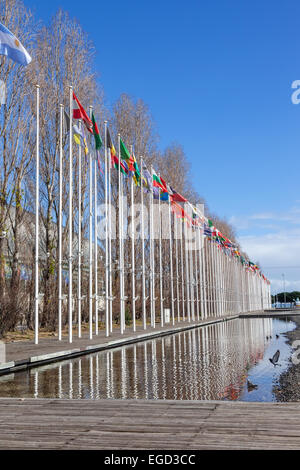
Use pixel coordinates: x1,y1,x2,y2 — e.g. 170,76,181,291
69,86,73,343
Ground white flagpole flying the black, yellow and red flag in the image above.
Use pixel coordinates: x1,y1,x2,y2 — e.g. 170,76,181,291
104,121,110,337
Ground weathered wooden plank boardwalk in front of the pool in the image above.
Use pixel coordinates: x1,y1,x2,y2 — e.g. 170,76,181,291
0,399,300,450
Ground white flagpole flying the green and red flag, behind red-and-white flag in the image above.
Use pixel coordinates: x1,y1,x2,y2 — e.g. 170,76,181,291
89,106,93,339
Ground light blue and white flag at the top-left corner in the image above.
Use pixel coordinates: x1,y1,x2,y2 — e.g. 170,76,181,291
0,23,31,65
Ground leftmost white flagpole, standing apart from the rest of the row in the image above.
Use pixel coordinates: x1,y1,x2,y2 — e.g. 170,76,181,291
34,85,40,344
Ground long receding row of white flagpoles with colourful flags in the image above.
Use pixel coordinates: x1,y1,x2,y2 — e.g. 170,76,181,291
35,85,270,344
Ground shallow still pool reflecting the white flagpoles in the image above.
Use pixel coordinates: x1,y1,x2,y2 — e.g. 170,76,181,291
0,318,296,401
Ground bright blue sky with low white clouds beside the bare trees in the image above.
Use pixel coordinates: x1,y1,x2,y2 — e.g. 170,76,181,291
24,0,300,291
